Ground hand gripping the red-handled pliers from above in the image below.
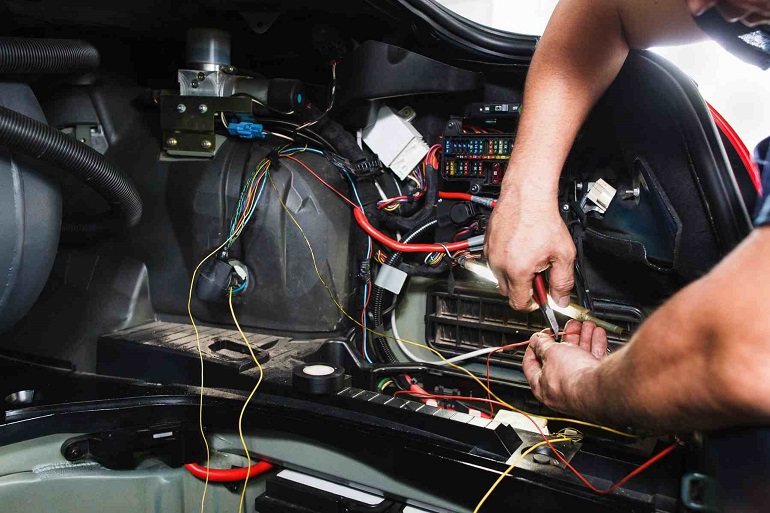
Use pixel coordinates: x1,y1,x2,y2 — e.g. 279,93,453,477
484,183,575,310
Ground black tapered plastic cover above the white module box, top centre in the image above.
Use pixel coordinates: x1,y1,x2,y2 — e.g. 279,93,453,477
337,41,483,104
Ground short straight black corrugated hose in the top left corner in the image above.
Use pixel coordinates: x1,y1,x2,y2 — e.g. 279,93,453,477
0,37,99,75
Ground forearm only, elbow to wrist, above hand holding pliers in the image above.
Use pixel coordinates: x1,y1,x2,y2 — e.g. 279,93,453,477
502,0,628,202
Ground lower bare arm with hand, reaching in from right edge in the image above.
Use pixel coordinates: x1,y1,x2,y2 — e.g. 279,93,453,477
524,227,770,432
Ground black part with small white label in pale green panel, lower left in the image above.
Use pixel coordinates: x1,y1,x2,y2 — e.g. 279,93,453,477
61,423,206,470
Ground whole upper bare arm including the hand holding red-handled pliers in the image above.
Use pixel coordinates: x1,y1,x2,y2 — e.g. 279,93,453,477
485,0,704,310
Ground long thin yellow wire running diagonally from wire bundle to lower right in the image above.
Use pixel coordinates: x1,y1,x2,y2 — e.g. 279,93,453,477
267,173,638,438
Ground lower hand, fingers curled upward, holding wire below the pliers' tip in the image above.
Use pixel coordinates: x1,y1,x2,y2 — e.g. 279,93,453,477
523,320,607,415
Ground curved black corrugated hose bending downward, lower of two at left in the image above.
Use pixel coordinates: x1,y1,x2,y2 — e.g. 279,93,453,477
0,106,142,229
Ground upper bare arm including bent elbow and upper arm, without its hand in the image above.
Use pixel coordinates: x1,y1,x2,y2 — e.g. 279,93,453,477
501,0,705,203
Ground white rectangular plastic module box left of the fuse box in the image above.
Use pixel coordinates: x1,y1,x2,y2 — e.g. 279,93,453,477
363,107,430,180
